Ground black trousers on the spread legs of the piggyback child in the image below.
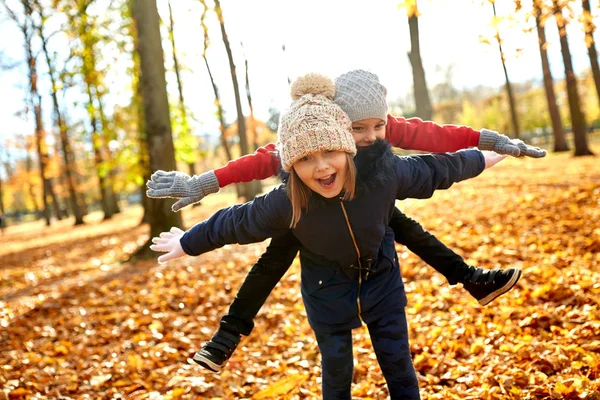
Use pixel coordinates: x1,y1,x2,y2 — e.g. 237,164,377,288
221,208,468,335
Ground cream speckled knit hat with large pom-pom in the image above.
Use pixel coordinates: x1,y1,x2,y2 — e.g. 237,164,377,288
277,73,356,172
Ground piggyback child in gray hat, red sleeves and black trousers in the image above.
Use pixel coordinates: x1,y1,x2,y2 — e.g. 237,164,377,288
148,70,528,372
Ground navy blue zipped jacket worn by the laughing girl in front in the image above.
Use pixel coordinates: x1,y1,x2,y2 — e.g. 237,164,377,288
181,146,484,332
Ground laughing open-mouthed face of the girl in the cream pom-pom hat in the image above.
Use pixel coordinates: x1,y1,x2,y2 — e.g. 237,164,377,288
293,150,348,199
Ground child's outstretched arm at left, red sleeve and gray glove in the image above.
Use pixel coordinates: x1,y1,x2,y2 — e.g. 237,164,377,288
146,143,280,211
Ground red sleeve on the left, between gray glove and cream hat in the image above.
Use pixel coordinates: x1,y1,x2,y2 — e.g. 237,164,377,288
215,143,281,187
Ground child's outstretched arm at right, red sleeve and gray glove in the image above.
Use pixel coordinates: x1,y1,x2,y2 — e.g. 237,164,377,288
386,115,546,158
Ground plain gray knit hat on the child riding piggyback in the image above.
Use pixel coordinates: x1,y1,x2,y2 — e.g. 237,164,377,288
334,69,388,122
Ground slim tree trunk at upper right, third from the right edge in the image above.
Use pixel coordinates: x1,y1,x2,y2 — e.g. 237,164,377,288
533,0,569,152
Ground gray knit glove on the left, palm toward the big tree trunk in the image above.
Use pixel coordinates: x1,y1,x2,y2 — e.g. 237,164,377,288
146,170,219,212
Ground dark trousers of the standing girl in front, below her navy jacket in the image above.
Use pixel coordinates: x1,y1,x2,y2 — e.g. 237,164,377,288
315,311,421,400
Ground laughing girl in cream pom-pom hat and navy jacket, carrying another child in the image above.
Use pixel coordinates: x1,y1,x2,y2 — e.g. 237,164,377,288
151,74,501,399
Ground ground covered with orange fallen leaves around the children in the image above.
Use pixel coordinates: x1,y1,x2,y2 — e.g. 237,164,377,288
0,148,600,399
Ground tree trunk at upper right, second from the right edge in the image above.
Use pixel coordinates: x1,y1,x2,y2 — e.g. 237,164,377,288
552,0,593,156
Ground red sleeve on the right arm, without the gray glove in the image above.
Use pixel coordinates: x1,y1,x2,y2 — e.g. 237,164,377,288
385,115,479,153
